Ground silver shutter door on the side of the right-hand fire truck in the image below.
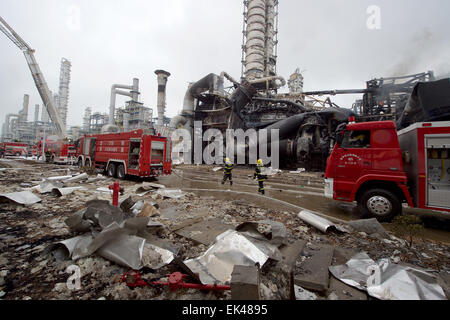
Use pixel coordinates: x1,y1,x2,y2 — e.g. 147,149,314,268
425,135,450,209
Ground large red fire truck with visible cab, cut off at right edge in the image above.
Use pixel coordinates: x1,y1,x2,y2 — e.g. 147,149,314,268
325,121,450,222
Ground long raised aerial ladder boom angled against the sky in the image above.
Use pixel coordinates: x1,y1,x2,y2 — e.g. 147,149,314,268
0,17,66,140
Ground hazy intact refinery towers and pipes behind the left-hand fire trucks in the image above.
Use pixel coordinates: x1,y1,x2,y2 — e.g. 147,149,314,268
1,63,171,144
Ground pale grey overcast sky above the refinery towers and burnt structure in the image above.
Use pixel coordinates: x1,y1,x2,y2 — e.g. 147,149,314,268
0,0,450,125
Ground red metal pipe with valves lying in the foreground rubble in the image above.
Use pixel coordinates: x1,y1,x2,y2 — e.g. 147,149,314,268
121,271,231,291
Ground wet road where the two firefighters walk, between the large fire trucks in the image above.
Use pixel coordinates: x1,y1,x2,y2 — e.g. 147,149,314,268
158,166,450,244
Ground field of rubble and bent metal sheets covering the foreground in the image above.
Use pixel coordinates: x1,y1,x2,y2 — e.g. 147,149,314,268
0,160,450,300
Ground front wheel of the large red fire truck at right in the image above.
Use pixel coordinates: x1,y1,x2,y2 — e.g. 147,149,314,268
358,189,402,222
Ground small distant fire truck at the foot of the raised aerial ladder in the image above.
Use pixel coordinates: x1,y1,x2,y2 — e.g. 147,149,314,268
37,140,77,164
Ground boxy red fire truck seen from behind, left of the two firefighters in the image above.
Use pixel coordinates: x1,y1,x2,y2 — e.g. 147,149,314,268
77,129,172,179
